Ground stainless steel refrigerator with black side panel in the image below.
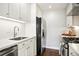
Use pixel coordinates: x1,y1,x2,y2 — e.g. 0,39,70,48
36,17,46,56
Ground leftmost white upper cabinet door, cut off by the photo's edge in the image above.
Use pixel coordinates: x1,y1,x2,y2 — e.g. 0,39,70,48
0,3,8,17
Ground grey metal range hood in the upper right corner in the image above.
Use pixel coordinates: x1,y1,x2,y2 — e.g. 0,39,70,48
68,3,79,16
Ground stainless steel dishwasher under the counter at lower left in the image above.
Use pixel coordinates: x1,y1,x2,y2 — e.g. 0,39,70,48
0,45,18,56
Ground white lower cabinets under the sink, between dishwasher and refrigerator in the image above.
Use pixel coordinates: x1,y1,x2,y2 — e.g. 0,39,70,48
18,37,36,56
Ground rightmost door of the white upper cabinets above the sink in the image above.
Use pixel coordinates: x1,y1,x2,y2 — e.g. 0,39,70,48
20,3,30,22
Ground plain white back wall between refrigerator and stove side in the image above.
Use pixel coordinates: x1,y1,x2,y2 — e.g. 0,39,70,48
43,10,66,49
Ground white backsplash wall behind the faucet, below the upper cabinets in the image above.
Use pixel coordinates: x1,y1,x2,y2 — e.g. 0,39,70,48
0,19,25,40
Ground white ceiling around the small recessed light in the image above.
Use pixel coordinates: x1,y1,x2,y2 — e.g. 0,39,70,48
38,3,67,11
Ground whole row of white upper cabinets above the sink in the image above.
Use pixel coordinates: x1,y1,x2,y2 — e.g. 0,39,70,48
0,3,31,22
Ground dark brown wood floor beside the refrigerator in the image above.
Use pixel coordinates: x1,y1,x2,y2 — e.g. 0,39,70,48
43,48,60,56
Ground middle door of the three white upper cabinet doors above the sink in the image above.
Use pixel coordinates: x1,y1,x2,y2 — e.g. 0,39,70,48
9,3,19,19
